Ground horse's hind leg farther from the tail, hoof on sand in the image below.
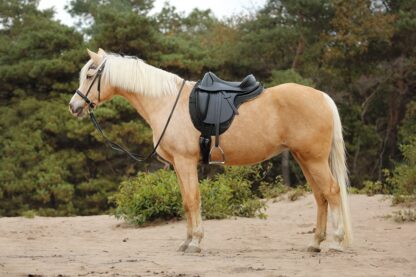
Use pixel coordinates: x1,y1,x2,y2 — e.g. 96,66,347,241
292,152,328,252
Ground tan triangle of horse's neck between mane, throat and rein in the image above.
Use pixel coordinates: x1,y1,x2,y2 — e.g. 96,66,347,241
116,87,176,131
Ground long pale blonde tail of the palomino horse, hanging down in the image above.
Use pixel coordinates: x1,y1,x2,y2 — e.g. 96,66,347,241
324,94,353,246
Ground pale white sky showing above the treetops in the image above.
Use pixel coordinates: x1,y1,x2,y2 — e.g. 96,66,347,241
39,0,266,26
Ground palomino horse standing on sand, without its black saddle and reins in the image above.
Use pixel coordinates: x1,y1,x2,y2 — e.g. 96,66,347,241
69,49,352,252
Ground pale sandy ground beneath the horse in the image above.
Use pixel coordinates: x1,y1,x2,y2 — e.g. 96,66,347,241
0,195,416,276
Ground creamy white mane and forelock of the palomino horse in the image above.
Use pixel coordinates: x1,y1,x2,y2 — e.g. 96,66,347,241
80,54,181,97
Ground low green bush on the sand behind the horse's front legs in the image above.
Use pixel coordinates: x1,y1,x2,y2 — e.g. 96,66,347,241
113,168,265,225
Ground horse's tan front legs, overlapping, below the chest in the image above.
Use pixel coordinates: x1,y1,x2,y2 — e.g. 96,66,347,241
174,158,204,253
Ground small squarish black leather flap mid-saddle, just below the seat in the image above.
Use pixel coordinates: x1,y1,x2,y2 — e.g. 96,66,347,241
203,93,236,124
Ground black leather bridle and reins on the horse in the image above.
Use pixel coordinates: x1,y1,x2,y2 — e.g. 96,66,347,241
76,60,186,162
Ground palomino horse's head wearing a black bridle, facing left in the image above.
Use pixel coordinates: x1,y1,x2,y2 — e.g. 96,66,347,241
69,48,111,117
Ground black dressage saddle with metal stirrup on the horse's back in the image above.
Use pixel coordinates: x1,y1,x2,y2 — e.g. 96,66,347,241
189,72,264,164
